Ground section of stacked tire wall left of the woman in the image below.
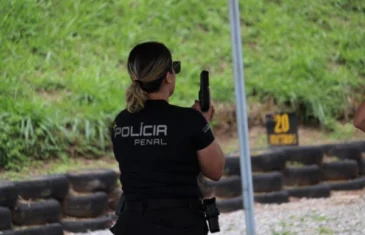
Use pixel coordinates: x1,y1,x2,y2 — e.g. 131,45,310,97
0,169,118,235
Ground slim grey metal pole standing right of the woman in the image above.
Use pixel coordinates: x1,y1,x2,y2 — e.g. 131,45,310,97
228,0,256,235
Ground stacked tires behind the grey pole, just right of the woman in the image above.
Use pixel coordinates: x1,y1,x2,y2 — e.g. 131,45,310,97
200,151,289,213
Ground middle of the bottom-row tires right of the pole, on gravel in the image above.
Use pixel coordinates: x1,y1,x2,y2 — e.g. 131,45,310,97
286,184,331,198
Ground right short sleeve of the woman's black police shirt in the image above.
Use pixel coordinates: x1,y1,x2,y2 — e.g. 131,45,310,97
188,109,215,150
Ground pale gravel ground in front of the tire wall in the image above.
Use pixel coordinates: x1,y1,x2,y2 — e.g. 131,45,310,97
68,190,365,235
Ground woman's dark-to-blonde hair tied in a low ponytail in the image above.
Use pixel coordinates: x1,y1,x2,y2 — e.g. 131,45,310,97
126,42,172,113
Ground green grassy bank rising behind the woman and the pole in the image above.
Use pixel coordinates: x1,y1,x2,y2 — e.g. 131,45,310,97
0,0,365,169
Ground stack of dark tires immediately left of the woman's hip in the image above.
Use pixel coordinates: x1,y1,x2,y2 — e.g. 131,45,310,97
61,169,118,233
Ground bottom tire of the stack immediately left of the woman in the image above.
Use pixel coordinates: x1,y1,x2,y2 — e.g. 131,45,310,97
61,216,113,233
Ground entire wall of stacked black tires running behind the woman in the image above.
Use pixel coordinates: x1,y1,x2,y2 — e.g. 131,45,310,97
0,141,365,235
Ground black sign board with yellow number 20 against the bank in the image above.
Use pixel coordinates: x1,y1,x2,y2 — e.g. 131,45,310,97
266,113,299,146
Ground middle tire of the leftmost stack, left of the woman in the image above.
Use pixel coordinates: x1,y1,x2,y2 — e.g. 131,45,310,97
12,199,62,226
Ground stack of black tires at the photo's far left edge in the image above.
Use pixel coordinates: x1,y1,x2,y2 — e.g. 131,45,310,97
0,175,69,235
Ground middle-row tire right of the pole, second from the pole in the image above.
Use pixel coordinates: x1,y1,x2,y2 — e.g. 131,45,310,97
283,165,322,186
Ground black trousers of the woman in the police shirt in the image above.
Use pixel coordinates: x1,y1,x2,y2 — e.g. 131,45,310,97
111,199,208,235
